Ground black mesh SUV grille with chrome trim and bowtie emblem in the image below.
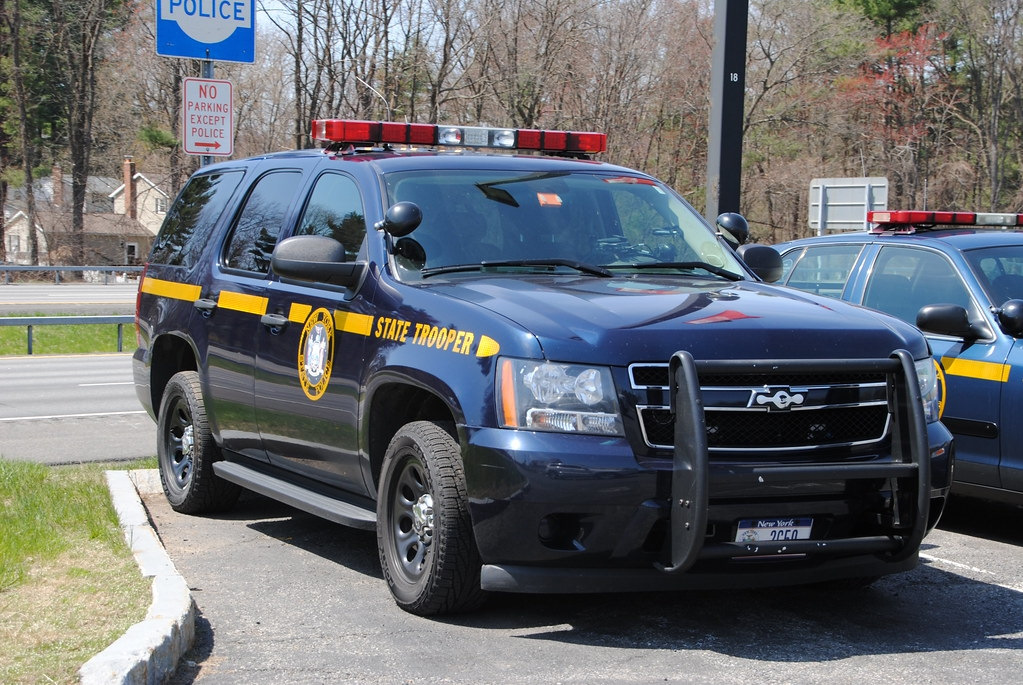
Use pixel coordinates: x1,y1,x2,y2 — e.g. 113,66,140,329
629,364,890,452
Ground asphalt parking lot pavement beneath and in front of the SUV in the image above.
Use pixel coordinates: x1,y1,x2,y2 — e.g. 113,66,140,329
144,486,1023,685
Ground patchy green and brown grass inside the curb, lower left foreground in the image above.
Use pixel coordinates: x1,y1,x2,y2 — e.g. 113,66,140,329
0,458,155,683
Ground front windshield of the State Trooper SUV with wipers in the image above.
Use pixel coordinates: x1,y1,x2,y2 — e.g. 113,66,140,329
386,170,746,280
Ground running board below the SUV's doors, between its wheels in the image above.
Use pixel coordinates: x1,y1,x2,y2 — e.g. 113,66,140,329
213,461,376,531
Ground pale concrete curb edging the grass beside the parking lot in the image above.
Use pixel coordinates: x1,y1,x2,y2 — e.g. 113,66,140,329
78,469,195,685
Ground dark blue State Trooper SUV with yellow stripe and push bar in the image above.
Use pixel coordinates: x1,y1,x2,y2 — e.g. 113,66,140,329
134,120,953,614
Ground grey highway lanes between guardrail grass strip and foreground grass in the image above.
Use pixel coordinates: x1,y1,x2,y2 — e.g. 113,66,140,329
0,354,157,464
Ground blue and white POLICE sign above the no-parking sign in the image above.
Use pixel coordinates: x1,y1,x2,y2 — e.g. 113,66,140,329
157,0,256,63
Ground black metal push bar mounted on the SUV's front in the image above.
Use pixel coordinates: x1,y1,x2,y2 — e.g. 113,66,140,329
657,350,931,574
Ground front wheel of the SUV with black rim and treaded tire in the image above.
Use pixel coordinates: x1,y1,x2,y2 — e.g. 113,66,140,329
376,421,486,615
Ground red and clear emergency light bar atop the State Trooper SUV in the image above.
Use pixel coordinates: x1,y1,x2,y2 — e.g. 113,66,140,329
312,119,608,154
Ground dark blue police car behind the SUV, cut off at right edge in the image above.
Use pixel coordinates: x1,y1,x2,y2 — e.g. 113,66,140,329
777,211,1023,504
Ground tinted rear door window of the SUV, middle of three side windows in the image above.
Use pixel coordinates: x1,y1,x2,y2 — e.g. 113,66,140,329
223,171,302,274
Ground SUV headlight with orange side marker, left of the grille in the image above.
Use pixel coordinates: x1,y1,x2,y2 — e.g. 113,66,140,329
497,358,624,436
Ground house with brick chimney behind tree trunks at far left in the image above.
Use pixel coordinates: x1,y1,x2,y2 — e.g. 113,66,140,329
4,157,169,266
